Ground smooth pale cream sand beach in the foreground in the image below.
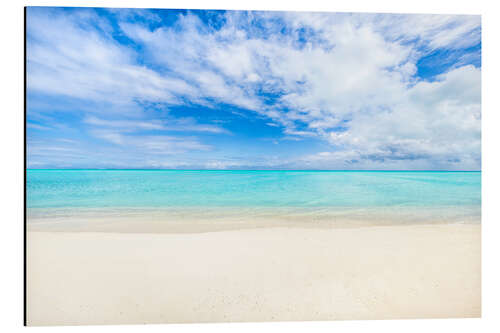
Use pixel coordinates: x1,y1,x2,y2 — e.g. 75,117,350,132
27,224,481,325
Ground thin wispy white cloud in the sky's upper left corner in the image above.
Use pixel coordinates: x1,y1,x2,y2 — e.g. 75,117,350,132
27,8,192,105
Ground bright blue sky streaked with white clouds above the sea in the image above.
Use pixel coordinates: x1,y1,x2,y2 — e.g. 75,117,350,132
27,7,481,170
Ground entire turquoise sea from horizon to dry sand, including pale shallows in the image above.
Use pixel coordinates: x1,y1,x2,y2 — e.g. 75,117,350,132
26,169,481,223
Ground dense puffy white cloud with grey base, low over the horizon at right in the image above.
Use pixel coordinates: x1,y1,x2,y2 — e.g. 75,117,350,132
317,66,481,169
